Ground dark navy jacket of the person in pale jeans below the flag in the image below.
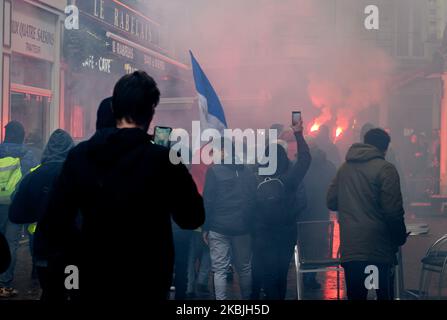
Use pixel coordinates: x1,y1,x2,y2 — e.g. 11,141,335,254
203,164,256,236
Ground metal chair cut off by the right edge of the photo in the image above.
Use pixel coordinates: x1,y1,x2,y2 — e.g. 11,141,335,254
419,234,447,299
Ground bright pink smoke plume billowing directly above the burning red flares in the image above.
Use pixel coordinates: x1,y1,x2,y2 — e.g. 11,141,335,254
307,45,393,130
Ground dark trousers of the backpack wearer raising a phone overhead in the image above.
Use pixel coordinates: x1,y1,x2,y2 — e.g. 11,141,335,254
252,231,296,300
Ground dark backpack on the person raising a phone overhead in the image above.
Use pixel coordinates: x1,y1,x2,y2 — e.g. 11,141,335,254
256,177,289,226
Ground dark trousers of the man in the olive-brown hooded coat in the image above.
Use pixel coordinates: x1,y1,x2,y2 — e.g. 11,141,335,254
342,261,394,300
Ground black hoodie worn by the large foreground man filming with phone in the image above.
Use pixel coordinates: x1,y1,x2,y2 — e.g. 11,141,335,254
38,128,204,300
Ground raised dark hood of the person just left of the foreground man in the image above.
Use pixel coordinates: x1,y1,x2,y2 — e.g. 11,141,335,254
42,129,74,163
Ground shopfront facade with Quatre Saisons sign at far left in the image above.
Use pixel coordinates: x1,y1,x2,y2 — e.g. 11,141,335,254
0,0,65,144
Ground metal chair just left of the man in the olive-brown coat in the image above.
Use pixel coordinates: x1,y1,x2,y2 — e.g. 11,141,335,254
295,221,343,300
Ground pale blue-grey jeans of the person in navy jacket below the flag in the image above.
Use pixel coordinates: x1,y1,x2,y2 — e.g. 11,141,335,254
208,231,252,300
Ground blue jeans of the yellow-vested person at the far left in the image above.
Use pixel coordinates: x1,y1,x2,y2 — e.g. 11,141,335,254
0,205,23,287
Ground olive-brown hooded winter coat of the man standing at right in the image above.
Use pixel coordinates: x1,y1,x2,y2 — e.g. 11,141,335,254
327,144,406,264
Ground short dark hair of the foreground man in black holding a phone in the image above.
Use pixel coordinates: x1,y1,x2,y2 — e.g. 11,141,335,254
112,71,160,127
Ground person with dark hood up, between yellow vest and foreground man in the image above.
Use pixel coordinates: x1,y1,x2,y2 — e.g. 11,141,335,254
9,129,74,300
